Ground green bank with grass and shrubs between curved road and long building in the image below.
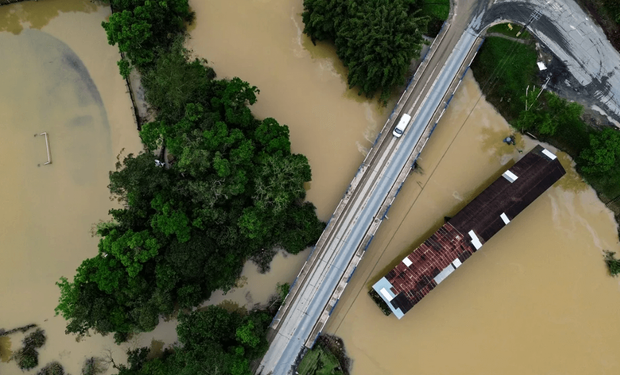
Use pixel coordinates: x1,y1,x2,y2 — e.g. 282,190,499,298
472,31,620,220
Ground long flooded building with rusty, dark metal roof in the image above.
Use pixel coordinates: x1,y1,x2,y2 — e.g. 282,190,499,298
373,146,566,319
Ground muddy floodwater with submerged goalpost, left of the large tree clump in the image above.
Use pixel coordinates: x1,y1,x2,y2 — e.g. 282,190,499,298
0,0,147,374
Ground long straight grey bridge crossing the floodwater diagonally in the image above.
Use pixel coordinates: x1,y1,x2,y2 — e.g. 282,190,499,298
256,0,490,375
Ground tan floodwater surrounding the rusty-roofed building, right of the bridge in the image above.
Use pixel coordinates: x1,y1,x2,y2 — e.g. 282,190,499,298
326,73,620,375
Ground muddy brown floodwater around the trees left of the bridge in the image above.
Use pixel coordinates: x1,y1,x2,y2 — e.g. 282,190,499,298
0,0,389,375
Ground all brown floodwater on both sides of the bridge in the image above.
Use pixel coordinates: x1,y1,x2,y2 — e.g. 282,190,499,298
0,0,620,375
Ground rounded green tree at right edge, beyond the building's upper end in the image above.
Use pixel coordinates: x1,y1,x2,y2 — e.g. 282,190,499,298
579,128,620,175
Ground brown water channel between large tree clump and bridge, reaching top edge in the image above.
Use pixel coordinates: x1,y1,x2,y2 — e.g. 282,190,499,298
188,0,395,221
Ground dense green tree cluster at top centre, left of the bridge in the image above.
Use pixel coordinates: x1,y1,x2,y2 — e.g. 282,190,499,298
302,0,428,102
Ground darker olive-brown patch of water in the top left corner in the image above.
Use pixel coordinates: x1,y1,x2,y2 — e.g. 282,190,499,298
0,0,98,35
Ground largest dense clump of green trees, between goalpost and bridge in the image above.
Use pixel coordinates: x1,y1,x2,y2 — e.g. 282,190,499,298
56,7,324,341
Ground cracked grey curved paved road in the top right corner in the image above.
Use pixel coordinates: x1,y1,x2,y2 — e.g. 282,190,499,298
481,0,620,127
